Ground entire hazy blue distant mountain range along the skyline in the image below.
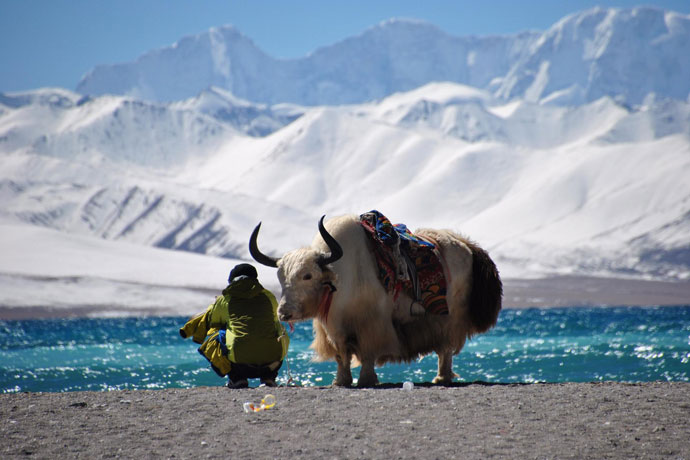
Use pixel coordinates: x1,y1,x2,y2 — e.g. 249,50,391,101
77,8,690,105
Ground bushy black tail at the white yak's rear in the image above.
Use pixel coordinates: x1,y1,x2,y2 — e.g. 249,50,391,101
465,241,503,333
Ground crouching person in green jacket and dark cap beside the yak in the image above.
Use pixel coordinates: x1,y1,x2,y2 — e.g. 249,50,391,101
180,264,290,388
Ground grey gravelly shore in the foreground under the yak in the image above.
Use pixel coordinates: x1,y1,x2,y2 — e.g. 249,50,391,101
0,383,690,459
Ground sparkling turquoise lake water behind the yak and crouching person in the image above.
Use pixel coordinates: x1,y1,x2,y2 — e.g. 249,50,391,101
0,306,690,393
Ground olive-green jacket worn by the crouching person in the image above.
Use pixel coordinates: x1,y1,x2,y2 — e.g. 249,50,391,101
180,278,290,364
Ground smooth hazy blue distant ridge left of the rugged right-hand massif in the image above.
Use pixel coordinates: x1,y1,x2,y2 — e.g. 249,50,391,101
77,20,538,105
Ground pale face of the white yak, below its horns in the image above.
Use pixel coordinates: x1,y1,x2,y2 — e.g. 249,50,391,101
278,248,333,321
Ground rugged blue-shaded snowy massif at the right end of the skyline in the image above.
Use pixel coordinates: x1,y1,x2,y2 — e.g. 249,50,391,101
496,8,690,104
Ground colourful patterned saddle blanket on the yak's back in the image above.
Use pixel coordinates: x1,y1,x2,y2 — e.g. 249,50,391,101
359,210,448,315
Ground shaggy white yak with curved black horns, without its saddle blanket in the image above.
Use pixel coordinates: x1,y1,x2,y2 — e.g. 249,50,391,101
249,215,502,387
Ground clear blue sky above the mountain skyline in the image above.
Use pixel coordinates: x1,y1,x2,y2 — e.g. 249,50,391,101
0,0,690,92
